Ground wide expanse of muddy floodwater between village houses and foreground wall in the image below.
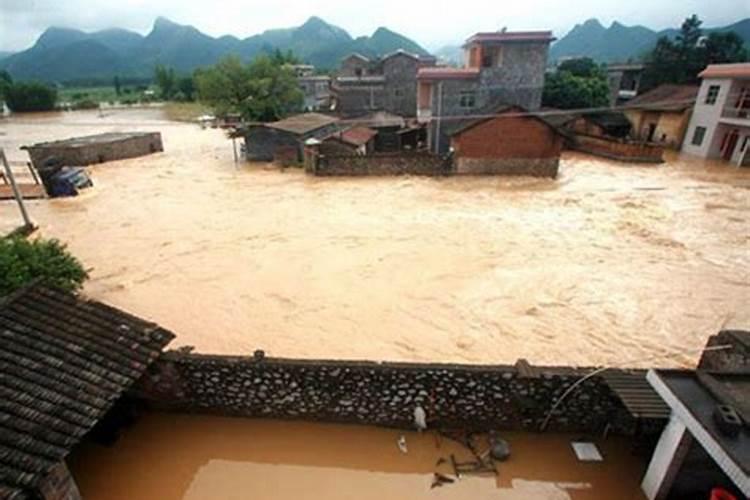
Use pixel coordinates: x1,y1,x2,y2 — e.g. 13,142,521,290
0,110,750,366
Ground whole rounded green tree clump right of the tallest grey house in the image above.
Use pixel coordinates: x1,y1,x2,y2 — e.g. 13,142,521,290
542,58,609,109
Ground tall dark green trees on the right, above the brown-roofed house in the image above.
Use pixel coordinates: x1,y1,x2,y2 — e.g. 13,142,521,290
643,15,748,89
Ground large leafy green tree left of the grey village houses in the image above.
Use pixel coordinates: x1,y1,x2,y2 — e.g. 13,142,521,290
195,56,303,121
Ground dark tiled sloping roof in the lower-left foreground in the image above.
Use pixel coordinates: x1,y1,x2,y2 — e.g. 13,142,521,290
0,284,174,498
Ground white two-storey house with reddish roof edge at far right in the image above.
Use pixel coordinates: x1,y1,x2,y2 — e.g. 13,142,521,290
682,63,750,166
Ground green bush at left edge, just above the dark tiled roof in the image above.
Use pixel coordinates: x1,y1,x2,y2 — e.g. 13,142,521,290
0,236,88,296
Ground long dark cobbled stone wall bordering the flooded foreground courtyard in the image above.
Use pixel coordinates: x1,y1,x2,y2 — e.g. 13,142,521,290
139,353,634,433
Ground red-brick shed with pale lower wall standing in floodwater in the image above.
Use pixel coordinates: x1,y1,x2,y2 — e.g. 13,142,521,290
445,106,563,177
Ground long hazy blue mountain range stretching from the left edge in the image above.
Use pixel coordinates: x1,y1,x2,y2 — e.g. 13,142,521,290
0,17,427,82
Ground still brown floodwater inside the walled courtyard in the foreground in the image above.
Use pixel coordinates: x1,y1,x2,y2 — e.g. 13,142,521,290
69,414,645,500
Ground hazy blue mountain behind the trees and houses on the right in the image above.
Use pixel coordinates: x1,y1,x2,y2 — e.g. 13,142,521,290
550,18,750,62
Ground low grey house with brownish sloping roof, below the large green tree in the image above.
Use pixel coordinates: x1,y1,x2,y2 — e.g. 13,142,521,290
241,113,339,164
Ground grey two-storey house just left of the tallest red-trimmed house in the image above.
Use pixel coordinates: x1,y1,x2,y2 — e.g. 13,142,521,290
332,50,435,117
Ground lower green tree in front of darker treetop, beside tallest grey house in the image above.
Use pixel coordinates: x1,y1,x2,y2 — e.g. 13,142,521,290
542,71,609,109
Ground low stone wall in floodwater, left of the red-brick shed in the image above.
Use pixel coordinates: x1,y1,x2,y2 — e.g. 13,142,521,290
309,151,451,176
